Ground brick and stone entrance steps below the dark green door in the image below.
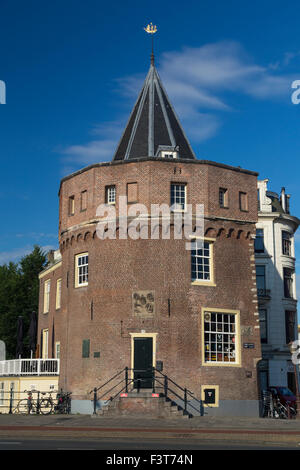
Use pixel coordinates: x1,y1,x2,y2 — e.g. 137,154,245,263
97,389,193,419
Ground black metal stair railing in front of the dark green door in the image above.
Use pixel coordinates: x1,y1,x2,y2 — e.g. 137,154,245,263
90,367,204,416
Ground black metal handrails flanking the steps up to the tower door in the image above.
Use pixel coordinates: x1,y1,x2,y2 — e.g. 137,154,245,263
90,367,204,416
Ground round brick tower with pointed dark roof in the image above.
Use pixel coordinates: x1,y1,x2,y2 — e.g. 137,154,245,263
38,53,261,416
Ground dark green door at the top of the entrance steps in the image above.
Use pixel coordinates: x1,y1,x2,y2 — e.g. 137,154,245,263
133,337,153,388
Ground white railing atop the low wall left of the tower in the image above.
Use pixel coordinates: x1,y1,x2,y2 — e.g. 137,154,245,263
0,359,59,376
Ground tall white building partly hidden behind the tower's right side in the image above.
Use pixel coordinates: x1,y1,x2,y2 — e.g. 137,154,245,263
255,179,300,391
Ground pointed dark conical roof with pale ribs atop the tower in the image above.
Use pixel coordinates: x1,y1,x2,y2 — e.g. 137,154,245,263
113,54,196,160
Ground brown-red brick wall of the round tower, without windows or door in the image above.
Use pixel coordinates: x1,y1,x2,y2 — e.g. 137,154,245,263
40,159,261,400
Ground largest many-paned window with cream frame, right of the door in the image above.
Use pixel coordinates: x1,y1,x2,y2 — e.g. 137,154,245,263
203,309,239,365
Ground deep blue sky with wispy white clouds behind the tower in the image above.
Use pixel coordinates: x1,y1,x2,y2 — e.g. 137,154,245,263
0,0,300,288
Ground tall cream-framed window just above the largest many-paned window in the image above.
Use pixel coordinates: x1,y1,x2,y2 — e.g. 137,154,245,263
191,239,214,285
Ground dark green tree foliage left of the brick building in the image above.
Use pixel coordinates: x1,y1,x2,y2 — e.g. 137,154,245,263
0,245,46,359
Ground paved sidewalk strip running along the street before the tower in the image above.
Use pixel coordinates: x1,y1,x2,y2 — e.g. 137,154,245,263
0,414,300,449
